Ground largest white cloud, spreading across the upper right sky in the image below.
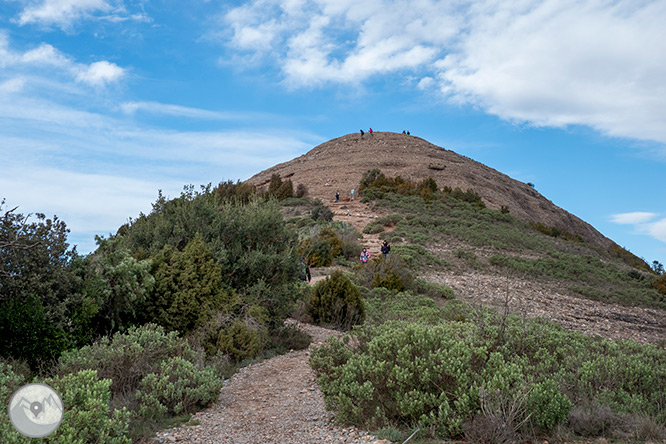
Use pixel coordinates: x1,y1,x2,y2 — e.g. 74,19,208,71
224,0,666,143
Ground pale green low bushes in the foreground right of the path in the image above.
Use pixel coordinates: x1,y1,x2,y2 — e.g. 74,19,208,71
310,312,666,442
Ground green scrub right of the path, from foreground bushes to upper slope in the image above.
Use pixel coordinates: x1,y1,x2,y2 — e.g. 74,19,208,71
310,171,666,443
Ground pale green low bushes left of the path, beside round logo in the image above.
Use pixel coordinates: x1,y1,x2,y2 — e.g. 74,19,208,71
54,324,222,442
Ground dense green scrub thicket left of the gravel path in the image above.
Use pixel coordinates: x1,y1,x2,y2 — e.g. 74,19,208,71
0,178,309,444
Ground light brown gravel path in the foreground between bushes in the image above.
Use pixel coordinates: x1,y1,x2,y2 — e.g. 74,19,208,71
155,321,389,444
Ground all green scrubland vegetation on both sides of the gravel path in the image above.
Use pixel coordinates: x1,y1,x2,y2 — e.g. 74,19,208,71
0,170,666,444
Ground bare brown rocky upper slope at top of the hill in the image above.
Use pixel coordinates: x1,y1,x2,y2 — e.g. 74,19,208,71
248,132,613,247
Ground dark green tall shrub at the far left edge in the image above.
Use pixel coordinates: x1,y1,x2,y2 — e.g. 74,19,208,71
0,203,78,370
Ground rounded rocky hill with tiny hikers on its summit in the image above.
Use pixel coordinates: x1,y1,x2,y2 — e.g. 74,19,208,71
248,133,666,343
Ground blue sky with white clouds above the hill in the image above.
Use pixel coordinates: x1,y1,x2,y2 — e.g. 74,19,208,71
0,0,666,263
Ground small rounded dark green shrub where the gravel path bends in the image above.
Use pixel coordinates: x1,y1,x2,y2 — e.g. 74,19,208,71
308,270,365,328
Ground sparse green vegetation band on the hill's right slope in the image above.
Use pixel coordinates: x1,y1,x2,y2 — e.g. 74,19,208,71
366,172,666,308
